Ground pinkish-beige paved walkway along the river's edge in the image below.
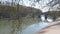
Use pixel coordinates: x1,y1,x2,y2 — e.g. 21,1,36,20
36,18,60,34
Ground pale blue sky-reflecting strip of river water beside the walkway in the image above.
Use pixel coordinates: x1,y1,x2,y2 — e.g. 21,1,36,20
21,22,49,34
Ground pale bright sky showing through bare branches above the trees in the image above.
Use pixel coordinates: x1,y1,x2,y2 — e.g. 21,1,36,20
0,0,52,12
